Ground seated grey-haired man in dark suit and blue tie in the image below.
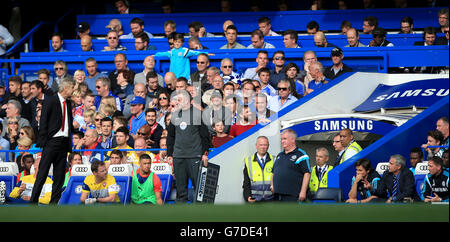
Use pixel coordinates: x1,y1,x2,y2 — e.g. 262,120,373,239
372,154,419,203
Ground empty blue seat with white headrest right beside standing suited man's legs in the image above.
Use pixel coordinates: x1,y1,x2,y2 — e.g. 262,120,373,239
58,164,92,205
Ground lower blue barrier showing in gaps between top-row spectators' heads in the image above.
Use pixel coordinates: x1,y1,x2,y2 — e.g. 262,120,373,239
53,34,444,51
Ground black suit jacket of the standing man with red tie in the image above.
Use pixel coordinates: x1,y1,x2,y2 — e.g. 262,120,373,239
36,94,74,152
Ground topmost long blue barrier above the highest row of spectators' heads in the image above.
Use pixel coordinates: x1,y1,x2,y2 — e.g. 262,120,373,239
77,8,439,35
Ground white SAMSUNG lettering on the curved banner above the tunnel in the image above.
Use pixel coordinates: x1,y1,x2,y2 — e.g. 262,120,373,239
314,120,373,131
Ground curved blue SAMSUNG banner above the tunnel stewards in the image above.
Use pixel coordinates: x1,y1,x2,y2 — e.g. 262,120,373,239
289,118,397,137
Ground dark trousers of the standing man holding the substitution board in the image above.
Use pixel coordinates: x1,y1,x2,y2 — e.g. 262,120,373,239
173,158,201,203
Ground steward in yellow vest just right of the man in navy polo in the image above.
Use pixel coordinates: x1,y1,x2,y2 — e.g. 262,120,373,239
309,147,333,197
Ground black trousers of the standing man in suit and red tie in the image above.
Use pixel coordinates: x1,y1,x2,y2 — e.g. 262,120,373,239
30,137,70,204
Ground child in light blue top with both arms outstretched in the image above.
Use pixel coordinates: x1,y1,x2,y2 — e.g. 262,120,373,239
155,33,208,79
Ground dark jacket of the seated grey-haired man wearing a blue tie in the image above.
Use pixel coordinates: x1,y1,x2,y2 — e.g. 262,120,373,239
375,167,419,201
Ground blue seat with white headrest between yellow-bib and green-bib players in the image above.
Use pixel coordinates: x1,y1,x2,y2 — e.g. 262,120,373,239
108,164,133,205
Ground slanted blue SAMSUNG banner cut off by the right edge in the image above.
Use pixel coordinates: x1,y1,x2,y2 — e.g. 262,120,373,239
353,78,448,112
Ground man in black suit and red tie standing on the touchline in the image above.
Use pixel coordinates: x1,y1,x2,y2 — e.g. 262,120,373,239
30,78,75,204
